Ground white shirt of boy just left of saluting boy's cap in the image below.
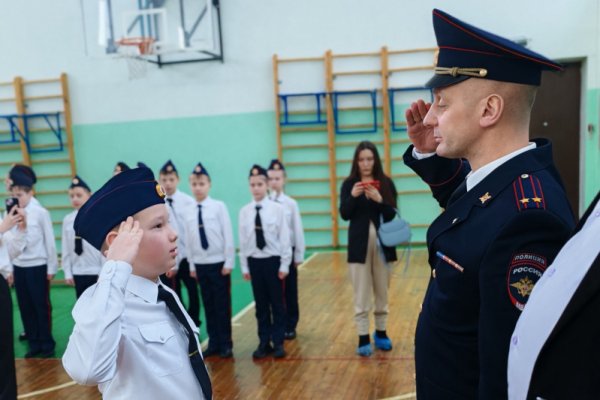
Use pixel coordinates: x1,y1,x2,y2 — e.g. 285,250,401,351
61,210,106,279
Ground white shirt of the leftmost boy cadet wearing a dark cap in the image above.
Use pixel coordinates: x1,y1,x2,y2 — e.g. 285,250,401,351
11,198,58,275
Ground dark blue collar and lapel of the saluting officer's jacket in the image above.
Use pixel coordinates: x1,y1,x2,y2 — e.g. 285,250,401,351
427,139,552,244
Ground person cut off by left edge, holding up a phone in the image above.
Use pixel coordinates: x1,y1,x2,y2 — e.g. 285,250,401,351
0,202,26,400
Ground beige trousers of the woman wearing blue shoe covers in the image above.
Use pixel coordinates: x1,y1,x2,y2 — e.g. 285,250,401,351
348,222,391,335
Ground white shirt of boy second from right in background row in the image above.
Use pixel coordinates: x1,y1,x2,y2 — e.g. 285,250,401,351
238,197,292,274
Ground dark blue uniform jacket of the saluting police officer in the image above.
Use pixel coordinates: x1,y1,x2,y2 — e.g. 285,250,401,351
404,139,574,400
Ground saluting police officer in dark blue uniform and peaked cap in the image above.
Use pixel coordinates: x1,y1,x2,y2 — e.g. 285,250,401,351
404,10,574,400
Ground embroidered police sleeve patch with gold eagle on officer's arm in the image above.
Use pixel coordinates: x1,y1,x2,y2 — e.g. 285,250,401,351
507,253,548,311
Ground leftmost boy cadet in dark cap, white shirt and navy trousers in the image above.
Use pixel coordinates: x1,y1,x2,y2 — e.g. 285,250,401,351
9,165,58,358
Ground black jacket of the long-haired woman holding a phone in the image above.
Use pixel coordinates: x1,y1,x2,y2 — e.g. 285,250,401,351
340,177,398,264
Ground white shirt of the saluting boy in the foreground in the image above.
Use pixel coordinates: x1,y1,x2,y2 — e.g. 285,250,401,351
62,260,204,400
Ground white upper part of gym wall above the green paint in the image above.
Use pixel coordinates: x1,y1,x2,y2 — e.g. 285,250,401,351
0,0,600,124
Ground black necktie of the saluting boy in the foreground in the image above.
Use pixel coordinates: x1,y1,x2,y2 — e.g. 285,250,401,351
158,285,212,400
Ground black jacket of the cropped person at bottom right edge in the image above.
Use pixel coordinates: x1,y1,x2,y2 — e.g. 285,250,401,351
527,192,600,400
